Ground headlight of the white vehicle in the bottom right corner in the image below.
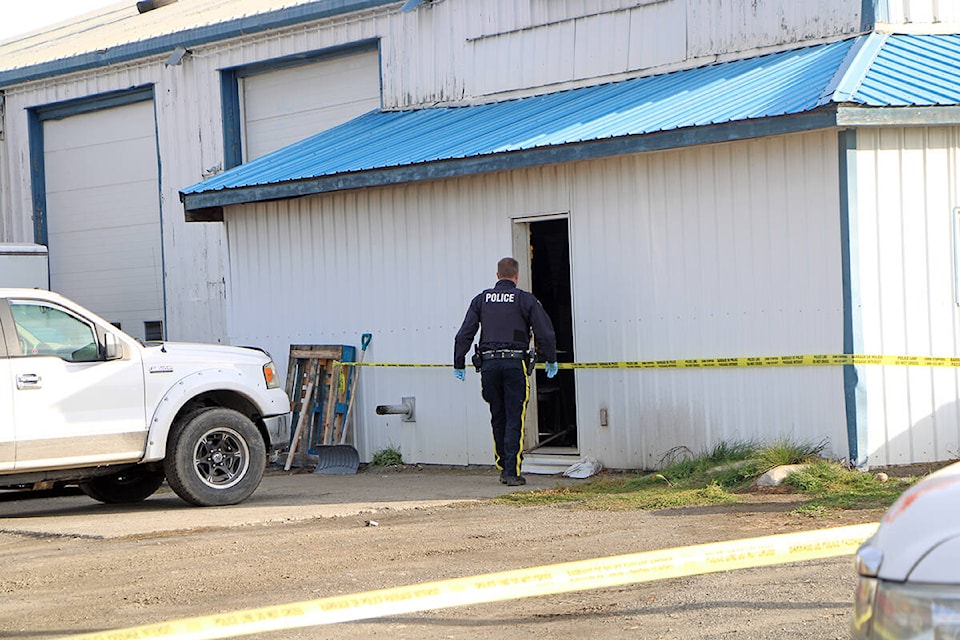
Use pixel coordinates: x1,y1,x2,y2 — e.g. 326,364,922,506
852,576,960,640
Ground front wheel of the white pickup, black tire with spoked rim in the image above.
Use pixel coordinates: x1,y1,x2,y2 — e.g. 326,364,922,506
164,407,267,507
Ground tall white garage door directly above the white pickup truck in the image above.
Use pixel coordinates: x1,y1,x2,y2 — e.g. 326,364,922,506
43,101,163,339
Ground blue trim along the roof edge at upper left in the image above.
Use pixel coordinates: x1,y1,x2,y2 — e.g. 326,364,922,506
0,0,398,88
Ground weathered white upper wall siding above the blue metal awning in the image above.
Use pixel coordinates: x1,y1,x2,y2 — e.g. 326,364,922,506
384,0,861,108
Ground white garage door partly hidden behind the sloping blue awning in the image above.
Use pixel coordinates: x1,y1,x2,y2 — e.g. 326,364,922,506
240,51,380,162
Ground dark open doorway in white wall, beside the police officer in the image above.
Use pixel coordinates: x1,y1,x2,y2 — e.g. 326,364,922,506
515,216,577,454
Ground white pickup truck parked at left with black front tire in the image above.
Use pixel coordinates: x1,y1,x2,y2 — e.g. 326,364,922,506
0,288,290,506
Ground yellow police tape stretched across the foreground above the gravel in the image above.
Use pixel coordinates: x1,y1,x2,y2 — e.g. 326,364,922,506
56,524,877,640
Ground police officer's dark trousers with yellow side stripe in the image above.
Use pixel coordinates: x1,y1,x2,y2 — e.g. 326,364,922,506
480,359,530,476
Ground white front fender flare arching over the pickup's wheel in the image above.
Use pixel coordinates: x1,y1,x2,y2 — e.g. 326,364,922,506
143,368,257,462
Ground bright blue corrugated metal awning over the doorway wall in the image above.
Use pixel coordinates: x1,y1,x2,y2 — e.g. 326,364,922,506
180,34,960,220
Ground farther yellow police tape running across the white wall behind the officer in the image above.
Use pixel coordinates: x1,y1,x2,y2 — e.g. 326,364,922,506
337,353,960,369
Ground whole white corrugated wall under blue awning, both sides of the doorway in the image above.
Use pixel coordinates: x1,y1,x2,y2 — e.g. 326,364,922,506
226,132,846,467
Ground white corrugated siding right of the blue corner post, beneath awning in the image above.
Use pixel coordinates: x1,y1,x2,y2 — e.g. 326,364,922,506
853,127,960,465
